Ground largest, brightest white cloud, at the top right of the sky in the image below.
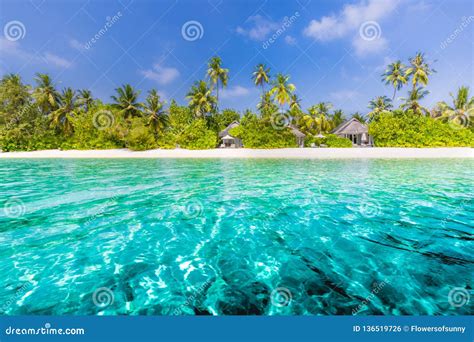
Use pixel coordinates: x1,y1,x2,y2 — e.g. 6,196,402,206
303,0,399,56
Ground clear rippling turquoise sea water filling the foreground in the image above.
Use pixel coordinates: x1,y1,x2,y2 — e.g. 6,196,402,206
0,160,474,315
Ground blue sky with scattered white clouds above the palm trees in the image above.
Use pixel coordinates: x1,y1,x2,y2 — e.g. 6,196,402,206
0,0,474,113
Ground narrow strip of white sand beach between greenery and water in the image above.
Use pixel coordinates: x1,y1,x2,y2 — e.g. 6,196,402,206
0,147,474,159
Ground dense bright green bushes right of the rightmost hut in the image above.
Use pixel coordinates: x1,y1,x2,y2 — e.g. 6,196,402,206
369,111,474,147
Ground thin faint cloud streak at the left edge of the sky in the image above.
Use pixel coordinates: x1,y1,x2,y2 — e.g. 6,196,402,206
0,38,73,69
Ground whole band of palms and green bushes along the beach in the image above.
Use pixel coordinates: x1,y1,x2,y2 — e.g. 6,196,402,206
0,53,474,151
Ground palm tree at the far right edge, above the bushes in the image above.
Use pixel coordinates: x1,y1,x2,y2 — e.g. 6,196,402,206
432,86,474,126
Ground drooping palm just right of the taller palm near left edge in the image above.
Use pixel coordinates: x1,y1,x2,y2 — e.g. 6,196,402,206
50,88,77,135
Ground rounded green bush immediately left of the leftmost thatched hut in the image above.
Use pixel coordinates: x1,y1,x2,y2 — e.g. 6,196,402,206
177,119,217,150
